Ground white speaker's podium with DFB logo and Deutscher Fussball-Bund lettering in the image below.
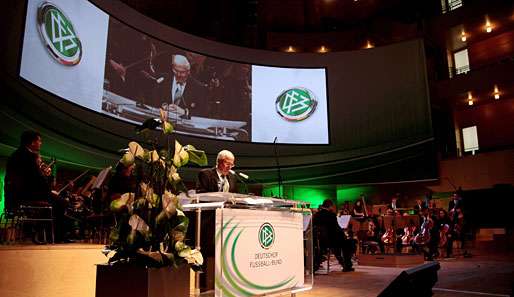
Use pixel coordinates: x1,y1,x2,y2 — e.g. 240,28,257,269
183,192,314,296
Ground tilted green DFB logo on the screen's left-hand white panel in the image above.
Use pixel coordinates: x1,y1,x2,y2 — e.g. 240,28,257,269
37,2,82,66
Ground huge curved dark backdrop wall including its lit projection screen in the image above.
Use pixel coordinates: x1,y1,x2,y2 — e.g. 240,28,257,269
0,0,437,185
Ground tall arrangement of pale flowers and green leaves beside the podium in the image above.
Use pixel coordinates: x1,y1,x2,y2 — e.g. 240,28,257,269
106,109,207,269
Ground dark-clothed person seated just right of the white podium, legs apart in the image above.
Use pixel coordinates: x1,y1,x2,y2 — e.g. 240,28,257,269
312,199,355,272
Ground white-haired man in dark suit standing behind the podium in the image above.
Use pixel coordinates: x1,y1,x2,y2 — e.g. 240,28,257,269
196,150,238,193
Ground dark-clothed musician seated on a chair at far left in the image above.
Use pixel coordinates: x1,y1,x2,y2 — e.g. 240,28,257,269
4,130,66,244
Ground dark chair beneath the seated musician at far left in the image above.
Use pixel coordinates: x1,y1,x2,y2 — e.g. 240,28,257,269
16,203,55,243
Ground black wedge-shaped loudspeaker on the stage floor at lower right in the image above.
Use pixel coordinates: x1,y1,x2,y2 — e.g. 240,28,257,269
377,262,441,297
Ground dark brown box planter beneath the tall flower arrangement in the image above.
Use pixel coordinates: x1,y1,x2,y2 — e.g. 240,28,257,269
95,264,190,297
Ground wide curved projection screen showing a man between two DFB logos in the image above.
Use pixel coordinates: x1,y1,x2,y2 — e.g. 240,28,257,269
20,0,329,144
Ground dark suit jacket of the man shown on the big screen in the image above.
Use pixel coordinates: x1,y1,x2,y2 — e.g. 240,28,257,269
150,74,210,117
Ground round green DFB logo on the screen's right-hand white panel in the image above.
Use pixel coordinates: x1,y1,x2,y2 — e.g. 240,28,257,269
275,87,318,122
